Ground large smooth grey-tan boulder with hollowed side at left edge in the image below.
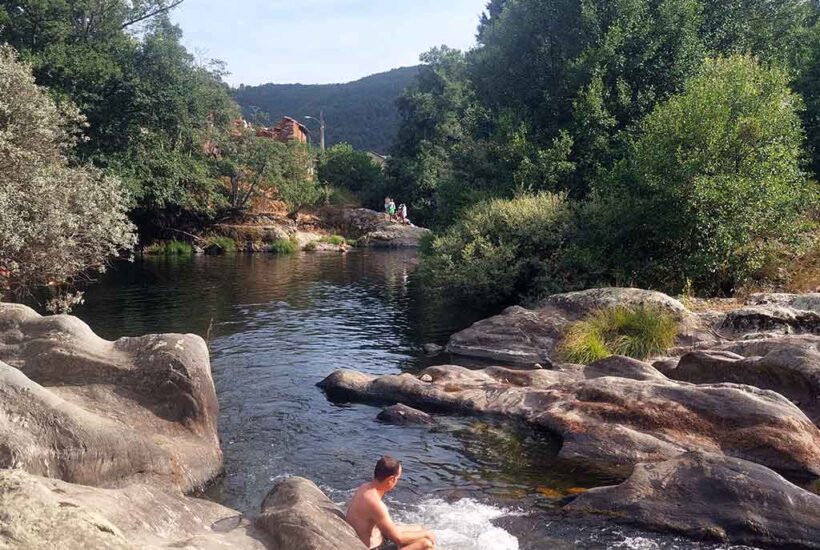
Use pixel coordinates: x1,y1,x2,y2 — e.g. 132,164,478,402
0,303,222,491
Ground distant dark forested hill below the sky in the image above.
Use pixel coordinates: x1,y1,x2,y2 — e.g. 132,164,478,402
234,67,418,153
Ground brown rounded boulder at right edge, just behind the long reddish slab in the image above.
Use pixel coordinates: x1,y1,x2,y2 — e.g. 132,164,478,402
667,346,820,424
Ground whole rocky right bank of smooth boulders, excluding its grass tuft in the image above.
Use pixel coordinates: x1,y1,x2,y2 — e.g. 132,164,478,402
321,288,820,548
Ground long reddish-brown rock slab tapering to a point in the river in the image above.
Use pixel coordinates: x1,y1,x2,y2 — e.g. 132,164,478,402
321,358,820,478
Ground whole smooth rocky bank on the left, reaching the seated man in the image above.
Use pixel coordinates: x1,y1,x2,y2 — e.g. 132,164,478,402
0,303,364,550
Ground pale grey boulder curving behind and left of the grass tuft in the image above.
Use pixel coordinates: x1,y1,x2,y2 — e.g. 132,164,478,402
447,288,715,365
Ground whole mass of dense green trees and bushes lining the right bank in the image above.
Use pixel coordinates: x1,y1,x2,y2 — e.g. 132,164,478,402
394,0,820,301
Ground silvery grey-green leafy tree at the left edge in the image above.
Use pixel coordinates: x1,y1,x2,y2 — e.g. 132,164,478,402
0,46,134,310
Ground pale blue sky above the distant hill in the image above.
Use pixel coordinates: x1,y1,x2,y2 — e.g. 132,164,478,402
172,0,486,85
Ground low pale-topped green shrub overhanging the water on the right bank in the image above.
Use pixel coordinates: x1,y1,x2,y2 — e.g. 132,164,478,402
421,193,570,303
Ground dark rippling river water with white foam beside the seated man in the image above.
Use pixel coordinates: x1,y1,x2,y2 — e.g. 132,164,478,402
75,251,752,550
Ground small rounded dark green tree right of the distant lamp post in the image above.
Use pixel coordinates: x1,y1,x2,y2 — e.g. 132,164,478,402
318,143,384,206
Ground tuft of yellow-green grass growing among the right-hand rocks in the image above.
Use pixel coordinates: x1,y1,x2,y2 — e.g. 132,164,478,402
558,308,678,365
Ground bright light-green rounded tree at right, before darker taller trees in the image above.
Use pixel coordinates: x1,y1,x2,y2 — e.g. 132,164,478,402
596,56,820,293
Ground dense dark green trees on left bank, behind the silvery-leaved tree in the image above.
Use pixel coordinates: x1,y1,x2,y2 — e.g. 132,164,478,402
0,0,326,237
